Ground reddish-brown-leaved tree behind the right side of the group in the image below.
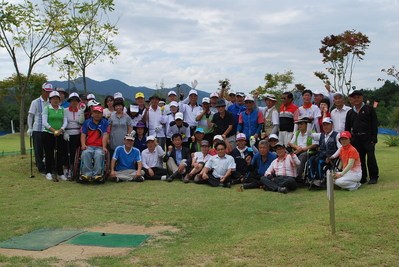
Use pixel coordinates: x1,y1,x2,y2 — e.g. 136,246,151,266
314,30,370,94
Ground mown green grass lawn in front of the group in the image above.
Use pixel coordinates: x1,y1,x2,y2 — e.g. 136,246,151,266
0,134,399,266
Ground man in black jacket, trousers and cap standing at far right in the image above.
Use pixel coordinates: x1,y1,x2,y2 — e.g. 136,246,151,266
345,90,378,184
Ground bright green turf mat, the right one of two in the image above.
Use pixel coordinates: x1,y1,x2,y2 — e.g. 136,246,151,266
64,232,151,248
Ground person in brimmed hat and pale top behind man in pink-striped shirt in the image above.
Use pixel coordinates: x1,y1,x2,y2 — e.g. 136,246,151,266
288,117,318,182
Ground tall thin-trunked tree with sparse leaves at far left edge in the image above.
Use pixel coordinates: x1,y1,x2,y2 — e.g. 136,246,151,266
0,0,113,154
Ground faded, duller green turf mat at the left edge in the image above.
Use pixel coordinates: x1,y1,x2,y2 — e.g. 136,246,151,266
0,229,85,250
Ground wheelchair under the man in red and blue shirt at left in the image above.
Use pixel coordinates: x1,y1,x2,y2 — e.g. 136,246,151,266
72,147,110,184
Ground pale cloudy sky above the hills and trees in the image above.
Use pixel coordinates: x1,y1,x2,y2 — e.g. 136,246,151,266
0,0,399,95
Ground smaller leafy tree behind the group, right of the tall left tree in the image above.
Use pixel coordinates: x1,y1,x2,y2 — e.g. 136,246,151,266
50,0,120,94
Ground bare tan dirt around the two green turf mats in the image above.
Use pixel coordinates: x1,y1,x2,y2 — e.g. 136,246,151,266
0,223,179,266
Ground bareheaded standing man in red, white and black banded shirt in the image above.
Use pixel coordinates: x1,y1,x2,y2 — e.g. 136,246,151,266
279,92,299,146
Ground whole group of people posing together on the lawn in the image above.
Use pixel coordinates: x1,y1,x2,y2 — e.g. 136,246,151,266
28,83,378,193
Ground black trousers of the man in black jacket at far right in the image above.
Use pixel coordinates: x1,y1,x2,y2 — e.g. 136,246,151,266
353,134,379,183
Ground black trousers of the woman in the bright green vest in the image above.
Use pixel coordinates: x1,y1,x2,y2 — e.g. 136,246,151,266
43,132,66,175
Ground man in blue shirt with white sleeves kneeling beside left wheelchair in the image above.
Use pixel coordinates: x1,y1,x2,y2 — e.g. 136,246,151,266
110,134,144,182
